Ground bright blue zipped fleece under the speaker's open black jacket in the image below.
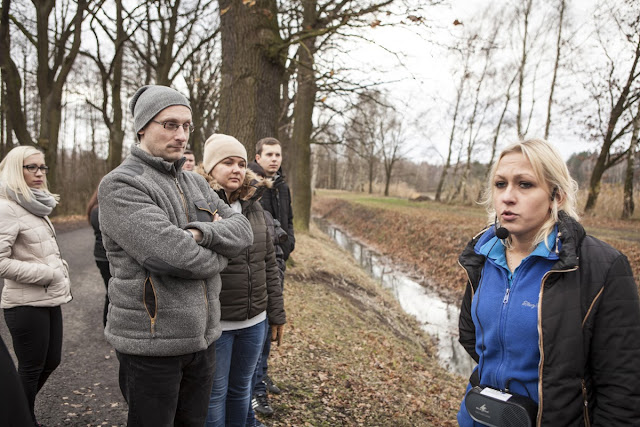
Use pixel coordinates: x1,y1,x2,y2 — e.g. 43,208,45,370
458,226,558,426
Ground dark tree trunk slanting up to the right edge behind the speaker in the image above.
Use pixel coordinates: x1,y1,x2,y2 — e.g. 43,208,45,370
584,37,640,212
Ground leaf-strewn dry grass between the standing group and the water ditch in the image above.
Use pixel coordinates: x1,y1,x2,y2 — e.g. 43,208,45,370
265,227,466,426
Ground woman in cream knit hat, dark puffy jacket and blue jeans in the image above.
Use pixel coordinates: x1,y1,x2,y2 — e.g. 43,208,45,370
198,134,286,427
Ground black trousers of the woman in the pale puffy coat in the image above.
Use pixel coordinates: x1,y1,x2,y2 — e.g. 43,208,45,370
4,306,62,422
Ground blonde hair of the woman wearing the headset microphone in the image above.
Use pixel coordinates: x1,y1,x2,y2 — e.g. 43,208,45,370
481,139,580,247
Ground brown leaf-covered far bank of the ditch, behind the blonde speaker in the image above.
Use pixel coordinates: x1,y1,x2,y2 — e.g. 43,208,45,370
314,191,640,300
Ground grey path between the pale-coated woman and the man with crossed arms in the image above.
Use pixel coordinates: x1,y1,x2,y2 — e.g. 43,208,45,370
0,226,127,426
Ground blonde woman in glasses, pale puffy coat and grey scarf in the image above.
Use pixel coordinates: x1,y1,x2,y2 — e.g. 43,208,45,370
0,146,71,425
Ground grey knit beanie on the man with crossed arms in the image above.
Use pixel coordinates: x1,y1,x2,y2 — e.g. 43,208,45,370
129,85,191,133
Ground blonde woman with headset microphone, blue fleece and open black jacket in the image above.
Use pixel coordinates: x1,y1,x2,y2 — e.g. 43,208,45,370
458,140,640,426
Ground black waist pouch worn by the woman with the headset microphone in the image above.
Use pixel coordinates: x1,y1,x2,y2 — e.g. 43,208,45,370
464,386,538,427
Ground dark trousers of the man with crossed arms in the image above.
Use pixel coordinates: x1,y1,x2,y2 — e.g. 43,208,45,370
116,344,216,427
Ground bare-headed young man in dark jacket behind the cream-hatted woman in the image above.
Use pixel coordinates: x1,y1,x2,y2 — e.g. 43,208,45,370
249,138,296,415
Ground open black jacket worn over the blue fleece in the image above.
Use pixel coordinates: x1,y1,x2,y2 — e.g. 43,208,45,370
459,212,640,427
